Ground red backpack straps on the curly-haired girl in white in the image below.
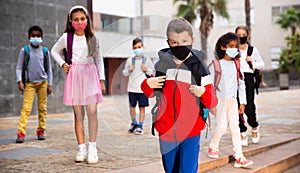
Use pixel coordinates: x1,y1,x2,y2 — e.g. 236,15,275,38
208,58,243,90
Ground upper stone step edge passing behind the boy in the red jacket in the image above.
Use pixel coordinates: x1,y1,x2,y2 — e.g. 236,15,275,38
110,134,300,173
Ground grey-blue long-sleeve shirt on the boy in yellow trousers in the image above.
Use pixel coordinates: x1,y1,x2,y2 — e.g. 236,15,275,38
16,45,52,86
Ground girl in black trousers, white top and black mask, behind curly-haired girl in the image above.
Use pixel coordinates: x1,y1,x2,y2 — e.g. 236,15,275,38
235,26,264,146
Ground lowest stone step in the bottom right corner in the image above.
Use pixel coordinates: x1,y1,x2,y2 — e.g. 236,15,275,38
205,140,300,173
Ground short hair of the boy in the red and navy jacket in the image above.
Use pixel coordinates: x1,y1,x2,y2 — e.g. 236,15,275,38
167,18,193,38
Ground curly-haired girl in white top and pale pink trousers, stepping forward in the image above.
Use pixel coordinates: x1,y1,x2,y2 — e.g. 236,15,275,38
208,32,253,167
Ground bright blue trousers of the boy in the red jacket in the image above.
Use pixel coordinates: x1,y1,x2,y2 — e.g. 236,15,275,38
159,135,200,173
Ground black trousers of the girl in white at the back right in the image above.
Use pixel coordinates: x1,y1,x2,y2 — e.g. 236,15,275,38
239,73,258,132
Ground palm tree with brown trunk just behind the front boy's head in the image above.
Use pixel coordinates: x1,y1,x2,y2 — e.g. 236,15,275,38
173,0,229,51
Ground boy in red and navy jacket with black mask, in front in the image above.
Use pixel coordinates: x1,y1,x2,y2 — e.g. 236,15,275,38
141,18,217,173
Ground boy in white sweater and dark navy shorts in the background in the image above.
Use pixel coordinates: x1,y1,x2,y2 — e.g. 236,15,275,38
123,38,153,135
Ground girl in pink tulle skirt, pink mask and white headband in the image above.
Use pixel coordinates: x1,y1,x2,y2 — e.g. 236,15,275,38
51,6,105,164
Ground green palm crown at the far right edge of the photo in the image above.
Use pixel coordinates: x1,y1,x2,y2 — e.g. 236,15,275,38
276,8,300,35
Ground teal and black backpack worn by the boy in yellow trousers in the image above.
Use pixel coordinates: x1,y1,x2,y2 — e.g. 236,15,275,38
22,45,49,88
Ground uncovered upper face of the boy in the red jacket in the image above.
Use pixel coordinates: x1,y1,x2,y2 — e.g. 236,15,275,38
167,31,194,47
